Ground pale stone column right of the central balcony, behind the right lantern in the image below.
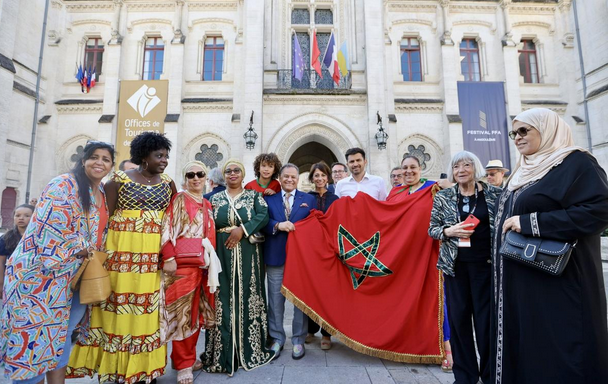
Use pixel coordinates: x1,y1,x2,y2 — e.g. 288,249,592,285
357,0,390,176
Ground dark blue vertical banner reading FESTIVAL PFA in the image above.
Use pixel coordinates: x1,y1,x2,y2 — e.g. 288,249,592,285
457,82,510,169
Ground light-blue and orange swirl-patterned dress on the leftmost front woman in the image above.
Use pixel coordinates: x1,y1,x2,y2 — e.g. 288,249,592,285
0,174,103,380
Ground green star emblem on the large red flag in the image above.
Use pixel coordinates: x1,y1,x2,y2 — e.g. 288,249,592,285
338,225,393,290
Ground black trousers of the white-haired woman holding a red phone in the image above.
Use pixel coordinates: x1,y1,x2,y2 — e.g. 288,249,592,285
444,259,492,384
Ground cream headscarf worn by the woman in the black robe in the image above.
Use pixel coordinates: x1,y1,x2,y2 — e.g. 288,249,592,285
508,108,587,191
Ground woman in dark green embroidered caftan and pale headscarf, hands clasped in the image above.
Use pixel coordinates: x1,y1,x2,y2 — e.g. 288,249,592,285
201,159,274,376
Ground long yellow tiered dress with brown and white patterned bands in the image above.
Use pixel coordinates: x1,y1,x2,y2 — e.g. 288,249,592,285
67,171,172,384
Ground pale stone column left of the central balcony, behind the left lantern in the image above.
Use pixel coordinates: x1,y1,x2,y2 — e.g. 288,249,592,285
240,0,264,172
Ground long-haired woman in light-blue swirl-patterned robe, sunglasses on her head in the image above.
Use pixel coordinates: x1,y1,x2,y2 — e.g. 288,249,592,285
0,142,114,384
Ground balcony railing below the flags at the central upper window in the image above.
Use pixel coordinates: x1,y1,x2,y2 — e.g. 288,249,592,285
277,69,351,91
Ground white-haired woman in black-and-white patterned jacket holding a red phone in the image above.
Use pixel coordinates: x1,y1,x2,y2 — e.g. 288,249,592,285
429,151,501,384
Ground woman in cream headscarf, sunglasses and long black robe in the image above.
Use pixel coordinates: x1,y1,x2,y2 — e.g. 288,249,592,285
491,108,607,383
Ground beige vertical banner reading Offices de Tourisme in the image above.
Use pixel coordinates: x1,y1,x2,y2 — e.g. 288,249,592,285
116,80,169,167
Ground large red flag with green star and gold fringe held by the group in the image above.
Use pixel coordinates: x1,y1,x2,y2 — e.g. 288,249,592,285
282,186,444,363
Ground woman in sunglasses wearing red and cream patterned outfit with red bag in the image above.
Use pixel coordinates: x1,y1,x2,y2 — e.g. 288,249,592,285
161,161,220,384
